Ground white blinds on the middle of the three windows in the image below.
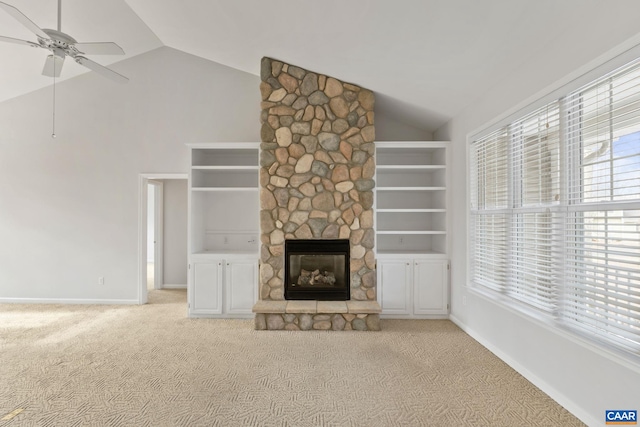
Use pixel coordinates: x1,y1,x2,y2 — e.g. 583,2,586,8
508,102,560,312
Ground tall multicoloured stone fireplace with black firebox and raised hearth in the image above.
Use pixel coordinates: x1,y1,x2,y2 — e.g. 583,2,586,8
254,58,380,330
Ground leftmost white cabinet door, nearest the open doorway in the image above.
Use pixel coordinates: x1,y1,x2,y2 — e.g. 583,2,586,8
189,260,224,314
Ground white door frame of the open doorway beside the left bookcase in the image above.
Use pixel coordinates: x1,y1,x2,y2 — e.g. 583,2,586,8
138,173,189,304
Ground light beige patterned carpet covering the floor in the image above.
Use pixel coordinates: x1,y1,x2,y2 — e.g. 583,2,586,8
0,290,581,427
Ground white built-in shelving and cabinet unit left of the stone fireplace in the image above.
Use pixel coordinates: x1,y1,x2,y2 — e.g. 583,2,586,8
187,142,260,317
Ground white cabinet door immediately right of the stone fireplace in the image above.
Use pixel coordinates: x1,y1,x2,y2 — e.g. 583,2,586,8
378,260,412,315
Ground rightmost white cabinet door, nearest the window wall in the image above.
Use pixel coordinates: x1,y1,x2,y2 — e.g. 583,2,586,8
413,260,449,314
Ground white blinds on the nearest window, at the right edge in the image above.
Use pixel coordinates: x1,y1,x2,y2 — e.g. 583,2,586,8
561,64,640,350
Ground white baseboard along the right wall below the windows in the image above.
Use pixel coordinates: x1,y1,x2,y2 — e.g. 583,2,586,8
449,315,603,426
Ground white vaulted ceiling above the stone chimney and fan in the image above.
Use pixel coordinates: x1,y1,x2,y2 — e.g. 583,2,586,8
0,0,640,131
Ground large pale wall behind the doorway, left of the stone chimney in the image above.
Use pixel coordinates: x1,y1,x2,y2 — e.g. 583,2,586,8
0,47,260,302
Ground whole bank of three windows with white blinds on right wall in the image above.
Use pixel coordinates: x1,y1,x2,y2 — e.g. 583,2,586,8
470,58,640,355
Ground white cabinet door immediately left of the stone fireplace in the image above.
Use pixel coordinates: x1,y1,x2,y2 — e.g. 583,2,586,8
225,259,258,314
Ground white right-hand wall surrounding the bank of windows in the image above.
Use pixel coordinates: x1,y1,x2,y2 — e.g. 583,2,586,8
435,6,640,425
